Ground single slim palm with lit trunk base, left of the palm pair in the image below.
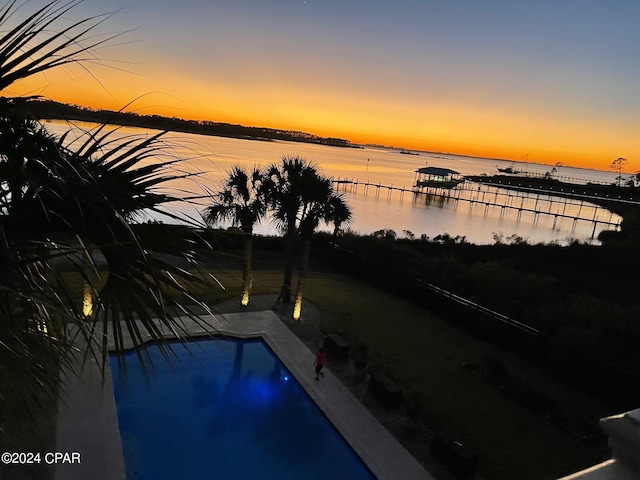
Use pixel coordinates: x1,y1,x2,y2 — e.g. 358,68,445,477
204,167,267,306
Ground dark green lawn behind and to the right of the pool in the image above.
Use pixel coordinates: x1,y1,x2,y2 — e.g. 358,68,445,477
191,270,617,480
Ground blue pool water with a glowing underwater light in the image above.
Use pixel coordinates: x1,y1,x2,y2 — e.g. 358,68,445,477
110,339,375,480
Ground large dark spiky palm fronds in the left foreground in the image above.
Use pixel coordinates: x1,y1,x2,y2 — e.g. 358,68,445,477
0,0,215,429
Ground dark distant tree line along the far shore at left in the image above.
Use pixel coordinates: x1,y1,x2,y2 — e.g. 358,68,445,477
22,100,356,148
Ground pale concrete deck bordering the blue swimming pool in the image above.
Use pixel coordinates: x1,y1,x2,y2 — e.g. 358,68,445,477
55,311,433,480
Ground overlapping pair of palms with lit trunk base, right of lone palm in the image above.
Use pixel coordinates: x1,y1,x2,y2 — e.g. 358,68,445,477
265,157,351,320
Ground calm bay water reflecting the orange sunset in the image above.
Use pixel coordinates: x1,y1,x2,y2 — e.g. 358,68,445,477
48,122,621,244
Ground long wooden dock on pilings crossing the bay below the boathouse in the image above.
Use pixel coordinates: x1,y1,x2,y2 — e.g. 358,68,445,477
333,178,624,238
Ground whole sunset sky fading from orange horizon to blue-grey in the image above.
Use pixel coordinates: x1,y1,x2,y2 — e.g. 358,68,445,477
8,0,640,171
